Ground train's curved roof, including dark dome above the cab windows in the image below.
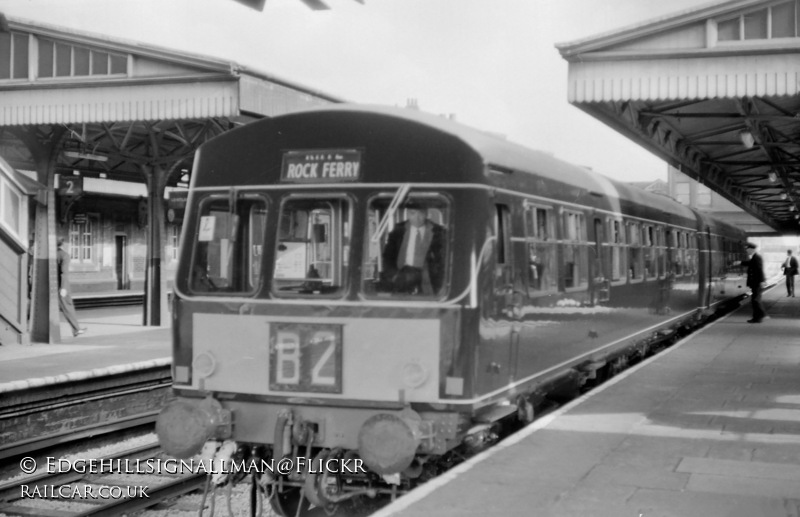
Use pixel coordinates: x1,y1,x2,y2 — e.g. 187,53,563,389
197,104,716,227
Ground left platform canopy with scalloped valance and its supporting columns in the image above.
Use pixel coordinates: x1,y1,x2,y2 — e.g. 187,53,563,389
0,17,339,342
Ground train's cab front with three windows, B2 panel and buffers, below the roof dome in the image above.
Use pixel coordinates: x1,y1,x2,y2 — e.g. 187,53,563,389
157,177,482,506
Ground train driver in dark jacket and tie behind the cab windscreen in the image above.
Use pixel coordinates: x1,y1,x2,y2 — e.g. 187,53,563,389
383,201,445,295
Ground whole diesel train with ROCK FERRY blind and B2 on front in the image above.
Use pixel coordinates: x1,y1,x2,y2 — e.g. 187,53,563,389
157,105,745,516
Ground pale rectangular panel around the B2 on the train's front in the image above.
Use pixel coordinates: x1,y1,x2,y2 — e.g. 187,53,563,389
190,313,442,403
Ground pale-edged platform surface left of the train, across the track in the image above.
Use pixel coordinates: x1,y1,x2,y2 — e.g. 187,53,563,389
0,306,172,390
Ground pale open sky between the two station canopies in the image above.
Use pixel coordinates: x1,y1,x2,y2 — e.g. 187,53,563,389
0,0,713,181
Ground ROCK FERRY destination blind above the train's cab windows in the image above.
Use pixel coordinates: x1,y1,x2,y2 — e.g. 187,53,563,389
281,149,361,183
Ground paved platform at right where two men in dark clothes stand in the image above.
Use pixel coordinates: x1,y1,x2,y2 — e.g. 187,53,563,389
372,283,800,517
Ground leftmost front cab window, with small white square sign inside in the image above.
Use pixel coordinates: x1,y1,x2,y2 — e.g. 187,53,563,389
189,195,267,293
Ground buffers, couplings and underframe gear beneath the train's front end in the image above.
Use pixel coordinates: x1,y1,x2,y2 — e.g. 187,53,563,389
164,397,520,517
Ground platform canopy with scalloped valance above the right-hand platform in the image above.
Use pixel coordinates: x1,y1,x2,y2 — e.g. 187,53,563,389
556,0,800,233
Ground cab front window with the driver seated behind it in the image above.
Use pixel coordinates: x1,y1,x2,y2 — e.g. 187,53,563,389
362,193,450,298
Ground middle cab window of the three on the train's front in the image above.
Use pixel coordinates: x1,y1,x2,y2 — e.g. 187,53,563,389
272,197,350,295
